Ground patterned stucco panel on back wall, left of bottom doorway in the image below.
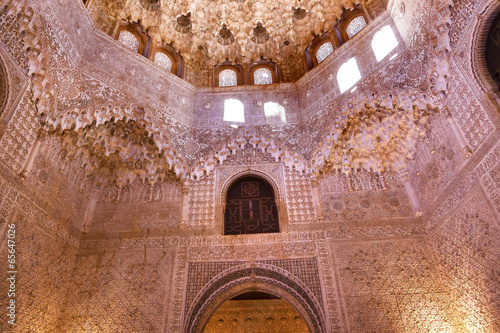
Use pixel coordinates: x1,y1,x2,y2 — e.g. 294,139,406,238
59,250,170,332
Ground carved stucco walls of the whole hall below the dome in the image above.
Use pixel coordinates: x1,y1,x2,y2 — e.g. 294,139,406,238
0,0,500,332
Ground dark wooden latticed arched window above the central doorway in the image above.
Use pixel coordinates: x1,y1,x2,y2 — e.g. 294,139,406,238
224,177,280,235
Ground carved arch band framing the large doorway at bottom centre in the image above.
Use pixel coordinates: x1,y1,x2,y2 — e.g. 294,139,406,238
184,263,327,333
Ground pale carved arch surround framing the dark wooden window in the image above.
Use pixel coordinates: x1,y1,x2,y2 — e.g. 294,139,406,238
216,168,288,236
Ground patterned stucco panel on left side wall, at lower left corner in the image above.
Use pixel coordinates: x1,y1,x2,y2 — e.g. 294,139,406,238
0,219,76,332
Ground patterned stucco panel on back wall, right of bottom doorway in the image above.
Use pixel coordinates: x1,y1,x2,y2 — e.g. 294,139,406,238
335,240,453,333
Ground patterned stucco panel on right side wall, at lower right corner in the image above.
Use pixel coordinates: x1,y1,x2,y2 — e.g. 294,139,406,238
432,191,500,332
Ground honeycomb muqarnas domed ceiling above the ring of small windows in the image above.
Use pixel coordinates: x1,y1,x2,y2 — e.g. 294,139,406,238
89,0,368,84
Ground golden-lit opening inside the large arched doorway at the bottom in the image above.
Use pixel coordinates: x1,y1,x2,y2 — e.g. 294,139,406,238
203,291,310,333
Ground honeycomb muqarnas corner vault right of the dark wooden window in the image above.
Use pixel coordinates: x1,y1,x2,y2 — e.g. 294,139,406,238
311,91,441,174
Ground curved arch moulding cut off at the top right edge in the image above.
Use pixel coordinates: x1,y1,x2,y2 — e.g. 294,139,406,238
471,0,500,106
